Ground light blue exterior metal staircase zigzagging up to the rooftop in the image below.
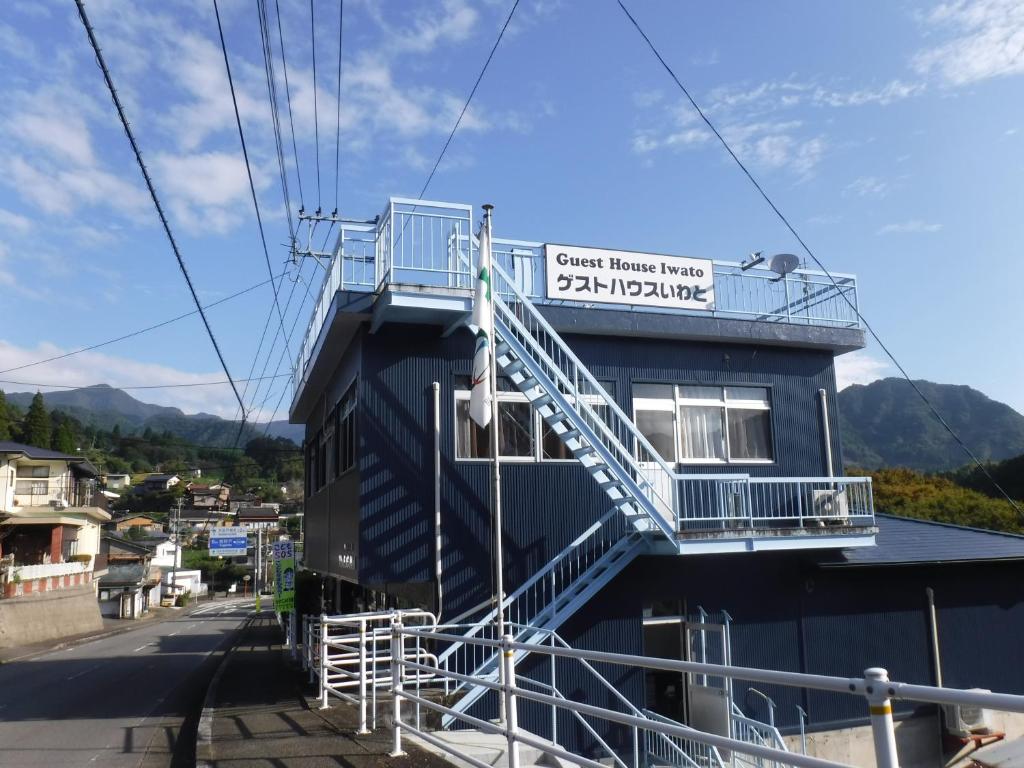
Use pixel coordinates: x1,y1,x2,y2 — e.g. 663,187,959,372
438,264,676,726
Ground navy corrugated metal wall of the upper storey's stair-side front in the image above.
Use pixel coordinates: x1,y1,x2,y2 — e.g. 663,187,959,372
359,326,839,615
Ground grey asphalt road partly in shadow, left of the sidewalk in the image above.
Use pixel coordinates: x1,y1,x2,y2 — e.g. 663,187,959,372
0,599,254,768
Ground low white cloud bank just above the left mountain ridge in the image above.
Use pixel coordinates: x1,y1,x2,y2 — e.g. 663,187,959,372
0,339,260,419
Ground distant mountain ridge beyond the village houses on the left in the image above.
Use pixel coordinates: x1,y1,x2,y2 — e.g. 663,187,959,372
7,384,303,446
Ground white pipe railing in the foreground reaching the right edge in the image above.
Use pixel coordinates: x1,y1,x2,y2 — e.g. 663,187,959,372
390,624,1024,768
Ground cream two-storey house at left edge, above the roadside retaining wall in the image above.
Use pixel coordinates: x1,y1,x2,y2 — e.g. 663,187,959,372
0,441,111,596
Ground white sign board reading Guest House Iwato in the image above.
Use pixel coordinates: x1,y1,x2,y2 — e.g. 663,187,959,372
544,245,715,309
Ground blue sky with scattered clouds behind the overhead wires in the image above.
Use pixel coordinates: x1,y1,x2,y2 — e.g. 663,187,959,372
0,0,1024,420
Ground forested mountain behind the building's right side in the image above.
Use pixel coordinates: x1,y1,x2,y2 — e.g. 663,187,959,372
839,378,1024,472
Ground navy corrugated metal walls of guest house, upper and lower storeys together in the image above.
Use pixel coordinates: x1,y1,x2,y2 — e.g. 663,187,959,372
307,326,1024,750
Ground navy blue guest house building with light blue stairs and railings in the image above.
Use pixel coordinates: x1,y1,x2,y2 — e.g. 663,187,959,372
291,199,1024,757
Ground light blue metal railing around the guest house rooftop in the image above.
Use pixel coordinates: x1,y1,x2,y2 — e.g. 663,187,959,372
295,198,860,389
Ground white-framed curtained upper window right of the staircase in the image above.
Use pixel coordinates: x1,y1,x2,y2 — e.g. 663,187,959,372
633,384,773,464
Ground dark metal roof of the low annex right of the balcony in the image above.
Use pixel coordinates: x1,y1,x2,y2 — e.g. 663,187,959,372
821,514,1024,566
